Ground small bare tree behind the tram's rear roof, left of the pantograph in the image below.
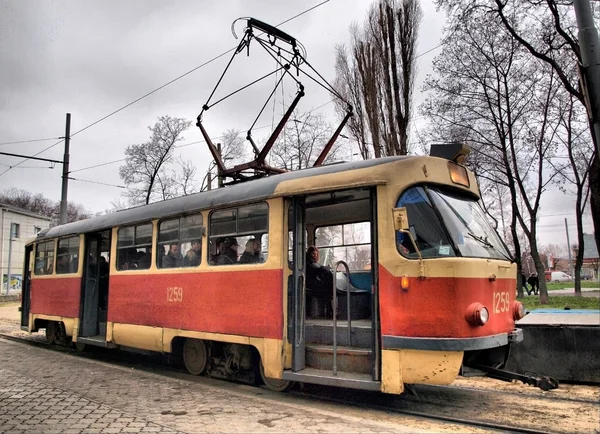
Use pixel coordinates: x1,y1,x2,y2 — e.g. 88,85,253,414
119,116,191,205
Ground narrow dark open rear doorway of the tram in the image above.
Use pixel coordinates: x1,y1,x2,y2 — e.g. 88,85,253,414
77,231,110,346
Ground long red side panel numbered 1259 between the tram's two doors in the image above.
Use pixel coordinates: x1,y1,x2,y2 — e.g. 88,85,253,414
108,270,283,339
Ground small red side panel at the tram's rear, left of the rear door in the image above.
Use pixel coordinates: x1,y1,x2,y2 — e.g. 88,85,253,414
30,277,81,318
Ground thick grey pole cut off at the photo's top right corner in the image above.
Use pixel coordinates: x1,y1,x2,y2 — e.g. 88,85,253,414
573,0,600,155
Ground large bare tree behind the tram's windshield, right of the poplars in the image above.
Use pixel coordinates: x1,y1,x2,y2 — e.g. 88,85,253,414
423,4,559,302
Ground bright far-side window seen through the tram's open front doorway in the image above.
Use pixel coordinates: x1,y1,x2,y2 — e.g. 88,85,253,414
315,222,371,271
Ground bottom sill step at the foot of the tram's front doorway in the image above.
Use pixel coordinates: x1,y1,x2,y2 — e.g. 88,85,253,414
283,368,381,391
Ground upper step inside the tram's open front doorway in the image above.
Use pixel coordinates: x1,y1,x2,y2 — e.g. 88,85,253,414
305,320,373,348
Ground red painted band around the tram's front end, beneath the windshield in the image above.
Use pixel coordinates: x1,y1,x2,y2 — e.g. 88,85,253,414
379,266,516,338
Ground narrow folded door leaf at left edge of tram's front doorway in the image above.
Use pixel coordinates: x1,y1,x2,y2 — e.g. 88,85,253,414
288,197,307,371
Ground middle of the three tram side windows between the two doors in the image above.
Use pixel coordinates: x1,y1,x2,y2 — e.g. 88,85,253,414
156,214,202,268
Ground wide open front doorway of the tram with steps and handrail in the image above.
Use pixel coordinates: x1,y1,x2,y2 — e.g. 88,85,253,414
282,186,381,390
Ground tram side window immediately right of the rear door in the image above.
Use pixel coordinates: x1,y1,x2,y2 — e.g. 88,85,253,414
117,223,152,270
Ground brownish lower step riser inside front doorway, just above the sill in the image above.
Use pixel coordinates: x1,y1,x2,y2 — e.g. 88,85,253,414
306,345,373,374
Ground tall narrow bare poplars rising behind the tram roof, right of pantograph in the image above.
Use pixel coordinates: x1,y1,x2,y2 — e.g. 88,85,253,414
335,0,422,159
